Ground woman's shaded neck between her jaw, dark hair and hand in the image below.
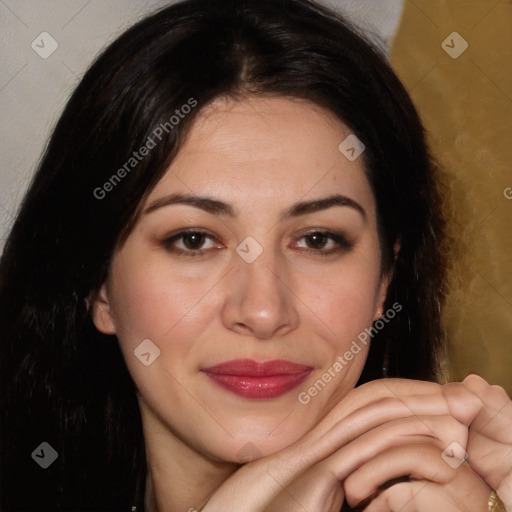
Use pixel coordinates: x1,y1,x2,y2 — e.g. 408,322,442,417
139,397,239,512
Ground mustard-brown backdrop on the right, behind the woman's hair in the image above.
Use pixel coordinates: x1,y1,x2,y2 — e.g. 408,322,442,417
391,0,512,394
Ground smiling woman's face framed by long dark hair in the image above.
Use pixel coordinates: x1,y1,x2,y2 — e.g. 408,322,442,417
94,98,387,462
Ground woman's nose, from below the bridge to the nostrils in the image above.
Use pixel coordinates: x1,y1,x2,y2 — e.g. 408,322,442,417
221,244,299,340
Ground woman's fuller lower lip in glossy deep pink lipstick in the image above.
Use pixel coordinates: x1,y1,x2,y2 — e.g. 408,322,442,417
200,370,311,400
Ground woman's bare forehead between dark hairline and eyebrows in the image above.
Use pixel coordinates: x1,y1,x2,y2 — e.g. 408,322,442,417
148,97,374,218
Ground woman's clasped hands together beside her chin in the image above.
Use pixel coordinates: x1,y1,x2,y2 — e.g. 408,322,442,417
202,375,512,512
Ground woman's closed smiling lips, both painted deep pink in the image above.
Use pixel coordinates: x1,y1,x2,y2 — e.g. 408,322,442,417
201,359,313,400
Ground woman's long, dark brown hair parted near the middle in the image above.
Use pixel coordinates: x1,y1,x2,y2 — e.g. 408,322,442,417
0,0,445,512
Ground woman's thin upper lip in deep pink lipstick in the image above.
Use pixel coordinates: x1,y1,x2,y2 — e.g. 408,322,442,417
201,359,313,377
